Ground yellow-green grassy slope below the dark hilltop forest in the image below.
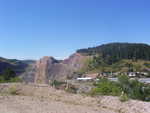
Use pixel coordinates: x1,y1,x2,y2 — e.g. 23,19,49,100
79,59,150,73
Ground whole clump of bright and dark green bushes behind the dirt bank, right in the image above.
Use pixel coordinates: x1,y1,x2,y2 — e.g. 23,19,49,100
90,75,150,101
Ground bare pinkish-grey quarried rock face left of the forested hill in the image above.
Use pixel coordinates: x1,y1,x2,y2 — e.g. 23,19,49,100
35,53,86,84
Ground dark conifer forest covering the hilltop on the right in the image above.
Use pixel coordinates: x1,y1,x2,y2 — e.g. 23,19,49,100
77,43,150,61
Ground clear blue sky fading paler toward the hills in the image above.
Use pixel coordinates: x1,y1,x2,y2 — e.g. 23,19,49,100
0,0,150,59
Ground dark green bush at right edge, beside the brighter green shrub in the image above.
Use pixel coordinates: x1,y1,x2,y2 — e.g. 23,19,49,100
118,75,150,101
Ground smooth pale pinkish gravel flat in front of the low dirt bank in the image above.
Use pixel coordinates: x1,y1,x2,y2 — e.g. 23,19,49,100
0,96,115,113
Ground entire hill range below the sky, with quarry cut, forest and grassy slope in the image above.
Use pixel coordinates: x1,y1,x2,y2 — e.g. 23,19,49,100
0,43,150,83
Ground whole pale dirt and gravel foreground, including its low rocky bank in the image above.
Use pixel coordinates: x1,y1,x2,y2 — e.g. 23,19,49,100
0,84,150,113
